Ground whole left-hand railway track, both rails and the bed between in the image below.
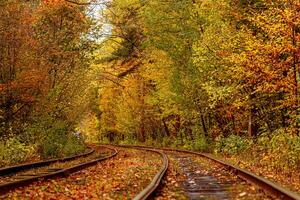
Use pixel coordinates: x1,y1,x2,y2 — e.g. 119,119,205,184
0,147,118,197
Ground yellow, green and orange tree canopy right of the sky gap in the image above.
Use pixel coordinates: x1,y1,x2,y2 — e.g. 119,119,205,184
97,0,300,141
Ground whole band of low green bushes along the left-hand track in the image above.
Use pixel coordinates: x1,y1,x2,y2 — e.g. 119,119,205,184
0,121,86,167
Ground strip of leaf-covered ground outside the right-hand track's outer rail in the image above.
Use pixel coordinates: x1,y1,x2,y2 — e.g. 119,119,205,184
217,154,300,194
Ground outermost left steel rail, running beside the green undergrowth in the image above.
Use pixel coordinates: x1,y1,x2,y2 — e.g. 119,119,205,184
0,149,94,176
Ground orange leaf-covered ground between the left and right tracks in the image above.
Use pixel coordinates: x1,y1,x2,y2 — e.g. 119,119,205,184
3,149,162,200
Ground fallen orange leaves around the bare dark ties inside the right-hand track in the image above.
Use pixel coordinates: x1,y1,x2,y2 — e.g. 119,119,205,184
155,153,272,200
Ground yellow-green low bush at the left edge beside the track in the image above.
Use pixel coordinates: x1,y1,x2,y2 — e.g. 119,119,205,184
0,137,36,167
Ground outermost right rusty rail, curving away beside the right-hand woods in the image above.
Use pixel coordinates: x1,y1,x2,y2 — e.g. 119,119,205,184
112,145,300,200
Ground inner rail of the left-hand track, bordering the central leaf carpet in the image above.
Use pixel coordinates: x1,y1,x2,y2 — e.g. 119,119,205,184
0,146,118,195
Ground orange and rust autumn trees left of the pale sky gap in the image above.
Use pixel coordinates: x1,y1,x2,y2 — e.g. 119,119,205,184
0,0,93,137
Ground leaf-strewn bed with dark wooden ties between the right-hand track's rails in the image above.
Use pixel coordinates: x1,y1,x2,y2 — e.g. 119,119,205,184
154,152,273,200
